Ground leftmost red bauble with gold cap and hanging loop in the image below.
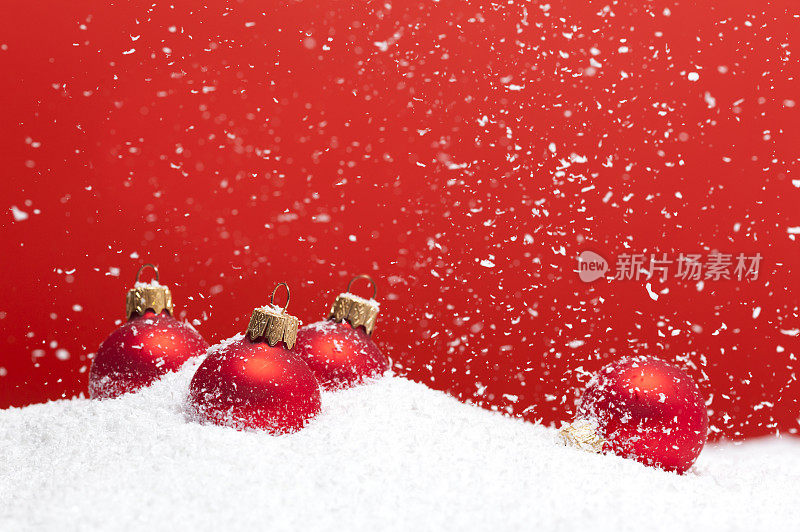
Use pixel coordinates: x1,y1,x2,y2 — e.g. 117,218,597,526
89,264,208,399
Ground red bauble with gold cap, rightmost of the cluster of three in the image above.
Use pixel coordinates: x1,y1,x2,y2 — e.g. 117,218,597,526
293,275,389,390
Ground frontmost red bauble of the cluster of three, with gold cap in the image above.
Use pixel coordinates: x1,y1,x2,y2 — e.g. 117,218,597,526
189,283,321,434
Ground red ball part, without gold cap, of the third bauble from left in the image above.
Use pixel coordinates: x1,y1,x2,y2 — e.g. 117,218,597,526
292,320,389,390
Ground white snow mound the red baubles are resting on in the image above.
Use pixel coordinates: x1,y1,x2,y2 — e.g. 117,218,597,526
0,361,800,531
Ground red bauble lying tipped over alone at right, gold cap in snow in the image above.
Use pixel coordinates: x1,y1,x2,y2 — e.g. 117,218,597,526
562,357,708,473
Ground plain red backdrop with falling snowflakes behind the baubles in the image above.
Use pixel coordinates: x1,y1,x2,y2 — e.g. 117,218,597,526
0,0,800,438
